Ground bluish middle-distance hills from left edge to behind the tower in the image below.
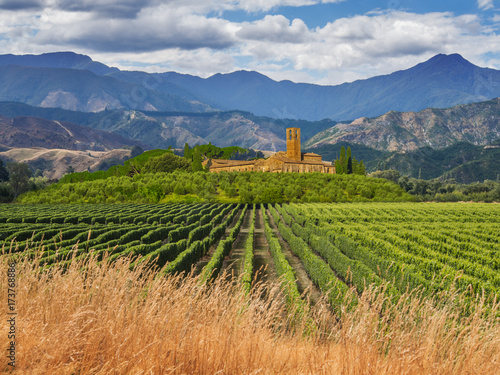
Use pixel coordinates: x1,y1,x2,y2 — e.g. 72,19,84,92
0,102,335,152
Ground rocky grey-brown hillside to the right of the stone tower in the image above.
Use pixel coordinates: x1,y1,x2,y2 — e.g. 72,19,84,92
304,98,500,152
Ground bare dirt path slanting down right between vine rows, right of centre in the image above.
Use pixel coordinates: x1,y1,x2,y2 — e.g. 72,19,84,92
267,210,322,304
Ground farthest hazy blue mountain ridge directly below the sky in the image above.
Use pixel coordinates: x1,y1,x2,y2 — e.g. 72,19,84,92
0,52,500,121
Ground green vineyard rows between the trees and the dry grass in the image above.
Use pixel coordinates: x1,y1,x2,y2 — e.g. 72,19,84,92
0,203,500,309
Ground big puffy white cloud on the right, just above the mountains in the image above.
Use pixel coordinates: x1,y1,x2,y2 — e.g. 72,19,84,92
241,12,500,83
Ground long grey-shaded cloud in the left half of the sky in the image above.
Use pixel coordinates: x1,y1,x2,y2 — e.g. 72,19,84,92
33,6,235,52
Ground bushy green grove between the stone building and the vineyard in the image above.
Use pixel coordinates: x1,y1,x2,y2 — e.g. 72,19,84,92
18,170,414,203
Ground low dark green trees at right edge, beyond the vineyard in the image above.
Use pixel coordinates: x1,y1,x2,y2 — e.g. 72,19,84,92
369,170,500,202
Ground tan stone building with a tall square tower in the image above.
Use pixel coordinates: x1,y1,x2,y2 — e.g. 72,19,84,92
204,128,335,174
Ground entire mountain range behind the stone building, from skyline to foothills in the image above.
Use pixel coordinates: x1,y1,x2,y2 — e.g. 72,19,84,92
0,52,500,182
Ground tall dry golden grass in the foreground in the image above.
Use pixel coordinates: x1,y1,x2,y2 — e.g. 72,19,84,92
0,251,500,374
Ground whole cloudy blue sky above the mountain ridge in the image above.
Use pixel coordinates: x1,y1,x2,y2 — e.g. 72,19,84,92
0,0,500,85
